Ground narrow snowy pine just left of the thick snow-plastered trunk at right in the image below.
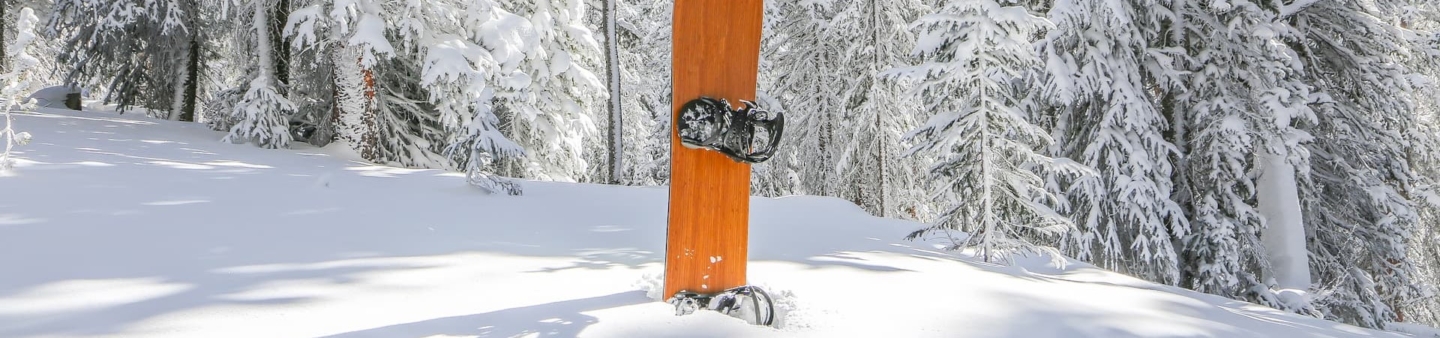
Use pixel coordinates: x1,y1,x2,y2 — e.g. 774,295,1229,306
1175,0,1263,302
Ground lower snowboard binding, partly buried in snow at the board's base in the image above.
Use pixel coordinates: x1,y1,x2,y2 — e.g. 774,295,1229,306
668,285,775,326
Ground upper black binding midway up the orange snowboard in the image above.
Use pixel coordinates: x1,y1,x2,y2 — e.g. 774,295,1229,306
675,96,785,164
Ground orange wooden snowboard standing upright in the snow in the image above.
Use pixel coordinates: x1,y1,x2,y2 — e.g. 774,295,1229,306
664,0,765,298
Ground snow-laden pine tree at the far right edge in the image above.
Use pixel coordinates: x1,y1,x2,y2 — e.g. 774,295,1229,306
1283,1,1440,328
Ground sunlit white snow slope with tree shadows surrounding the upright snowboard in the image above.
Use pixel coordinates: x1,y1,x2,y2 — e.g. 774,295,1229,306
0,109,1423,338
